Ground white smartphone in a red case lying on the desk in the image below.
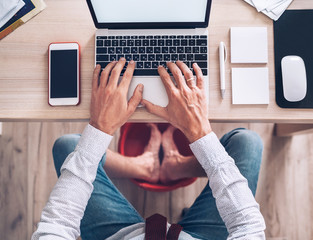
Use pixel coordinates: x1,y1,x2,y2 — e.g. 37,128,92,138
49,42,80,106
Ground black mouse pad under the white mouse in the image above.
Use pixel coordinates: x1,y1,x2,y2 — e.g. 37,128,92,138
274,10,313,108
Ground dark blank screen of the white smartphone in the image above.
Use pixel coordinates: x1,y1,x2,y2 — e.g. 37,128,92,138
50,50,78,98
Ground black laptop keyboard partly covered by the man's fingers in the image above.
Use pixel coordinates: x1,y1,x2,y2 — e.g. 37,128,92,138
96,35,208,76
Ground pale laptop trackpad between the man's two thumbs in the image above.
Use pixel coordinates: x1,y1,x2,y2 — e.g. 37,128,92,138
127,76,168,107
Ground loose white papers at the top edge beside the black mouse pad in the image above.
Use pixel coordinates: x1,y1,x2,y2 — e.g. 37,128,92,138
245,0,293,21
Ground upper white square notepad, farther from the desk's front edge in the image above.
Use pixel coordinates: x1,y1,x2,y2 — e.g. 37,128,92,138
230,27,268,63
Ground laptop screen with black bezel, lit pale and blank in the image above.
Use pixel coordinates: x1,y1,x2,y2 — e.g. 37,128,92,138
87,0,211,28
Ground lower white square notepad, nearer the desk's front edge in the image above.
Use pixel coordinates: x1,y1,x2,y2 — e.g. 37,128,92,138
232,68,269,104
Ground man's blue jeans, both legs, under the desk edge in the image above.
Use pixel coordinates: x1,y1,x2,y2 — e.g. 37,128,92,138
53,129,263,240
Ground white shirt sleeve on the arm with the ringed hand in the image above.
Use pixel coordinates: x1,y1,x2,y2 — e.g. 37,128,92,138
190,132,265,240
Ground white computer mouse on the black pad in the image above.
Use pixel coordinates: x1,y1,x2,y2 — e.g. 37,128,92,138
281,56,307,102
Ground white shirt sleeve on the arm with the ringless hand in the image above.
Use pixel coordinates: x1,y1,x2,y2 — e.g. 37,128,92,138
32,125,113,240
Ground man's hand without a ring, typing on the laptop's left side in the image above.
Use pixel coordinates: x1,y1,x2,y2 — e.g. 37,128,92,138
90,58,143,135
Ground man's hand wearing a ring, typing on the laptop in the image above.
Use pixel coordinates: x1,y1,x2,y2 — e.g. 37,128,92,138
141,61,212,142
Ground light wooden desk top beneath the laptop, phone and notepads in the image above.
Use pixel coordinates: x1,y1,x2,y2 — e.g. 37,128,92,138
0,0,313,123
